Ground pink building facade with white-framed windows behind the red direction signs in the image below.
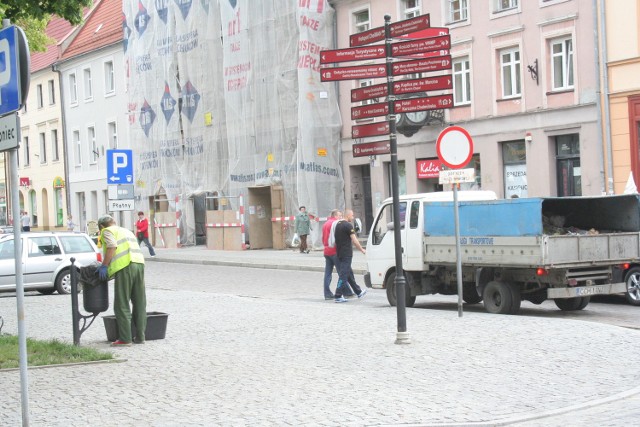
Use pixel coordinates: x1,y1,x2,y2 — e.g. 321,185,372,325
330,0,607,231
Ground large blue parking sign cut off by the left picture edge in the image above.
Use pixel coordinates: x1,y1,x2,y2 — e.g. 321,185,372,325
0,26,22,116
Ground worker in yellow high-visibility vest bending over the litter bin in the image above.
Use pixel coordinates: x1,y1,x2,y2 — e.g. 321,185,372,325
98,215,147,347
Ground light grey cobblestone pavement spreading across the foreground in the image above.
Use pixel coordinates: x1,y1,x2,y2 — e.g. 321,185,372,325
0,250,640,426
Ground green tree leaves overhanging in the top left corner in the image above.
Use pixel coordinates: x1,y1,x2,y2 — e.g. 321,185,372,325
0,0,93,25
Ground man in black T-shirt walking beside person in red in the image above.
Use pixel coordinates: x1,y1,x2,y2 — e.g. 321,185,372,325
334,209,367,302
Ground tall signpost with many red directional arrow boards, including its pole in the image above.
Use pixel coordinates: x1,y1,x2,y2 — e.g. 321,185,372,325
320,14,453,344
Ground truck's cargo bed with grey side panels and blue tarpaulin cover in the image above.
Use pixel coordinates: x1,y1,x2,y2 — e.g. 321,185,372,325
424,195,640,267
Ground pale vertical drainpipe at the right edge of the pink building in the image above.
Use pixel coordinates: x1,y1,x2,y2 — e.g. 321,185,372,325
593,0,614,194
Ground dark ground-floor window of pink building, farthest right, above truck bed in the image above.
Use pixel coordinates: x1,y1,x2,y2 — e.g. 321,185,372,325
555,134,582,197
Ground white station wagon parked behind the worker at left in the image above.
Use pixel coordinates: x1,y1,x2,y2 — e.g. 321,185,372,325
0,232,102,295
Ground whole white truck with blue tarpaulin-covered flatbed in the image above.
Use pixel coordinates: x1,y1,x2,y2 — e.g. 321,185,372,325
365,191,640,314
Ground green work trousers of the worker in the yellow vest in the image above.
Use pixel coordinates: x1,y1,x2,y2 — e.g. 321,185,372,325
113,262,147,342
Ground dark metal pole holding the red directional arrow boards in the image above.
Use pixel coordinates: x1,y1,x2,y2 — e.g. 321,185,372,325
384,15,411,344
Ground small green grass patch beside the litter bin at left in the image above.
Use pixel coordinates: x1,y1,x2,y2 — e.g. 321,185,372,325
0,334,113,369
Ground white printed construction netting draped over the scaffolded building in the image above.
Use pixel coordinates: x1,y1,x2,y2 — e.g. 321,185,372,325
123,0,344,244
